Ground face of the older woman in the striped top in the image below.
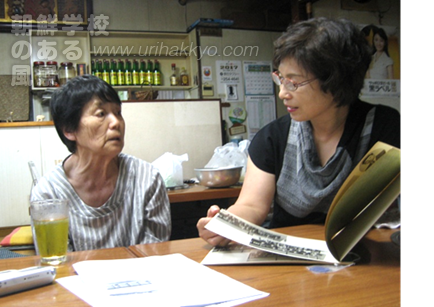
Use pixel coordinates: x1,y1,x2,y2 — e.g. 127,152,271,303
65,96,125,157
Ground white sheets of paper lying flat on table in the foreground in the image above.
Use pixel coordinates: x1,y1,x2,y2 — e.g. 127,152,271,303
57,254,269,307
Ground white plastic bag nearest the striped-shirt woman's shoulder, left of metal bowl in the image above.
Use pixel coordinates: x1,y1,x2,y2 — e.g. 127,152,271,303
152,152,188,188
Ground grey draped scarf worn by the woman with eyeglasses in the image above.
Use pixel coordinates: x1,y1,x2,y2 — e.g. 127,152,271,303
276,108,375,218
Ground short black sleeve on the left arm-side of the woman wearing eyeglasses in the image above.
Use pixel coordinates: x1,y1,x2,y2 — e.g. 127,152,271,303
249,115,291,180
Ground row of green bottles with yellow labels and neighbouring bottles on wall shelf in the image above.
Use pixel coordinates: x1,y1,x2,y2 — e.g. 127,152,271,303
92,59,189,86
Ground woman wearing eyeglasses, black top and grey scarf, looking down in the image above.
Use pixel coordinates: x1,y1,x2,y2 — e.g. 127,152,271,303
197,18,401,245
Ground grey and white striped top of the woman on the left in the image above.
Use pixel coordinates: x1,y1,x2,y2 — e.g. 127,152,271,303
32,154,171,251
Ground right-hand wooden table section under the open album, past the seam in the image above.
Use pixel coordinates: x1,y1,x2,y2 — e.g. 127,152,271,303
130,225,401,307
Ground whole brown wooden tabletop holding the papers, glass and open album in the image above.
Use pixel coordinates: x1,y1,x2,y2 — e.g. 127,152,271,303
0,225,401,307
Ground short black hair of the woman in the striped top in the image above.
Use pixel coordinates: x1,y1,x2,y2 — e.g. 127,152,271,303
50,75,122,153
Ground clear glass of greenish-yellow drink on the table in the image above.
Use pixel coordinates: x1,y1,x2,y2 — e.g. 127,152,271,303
30,199,69,265
